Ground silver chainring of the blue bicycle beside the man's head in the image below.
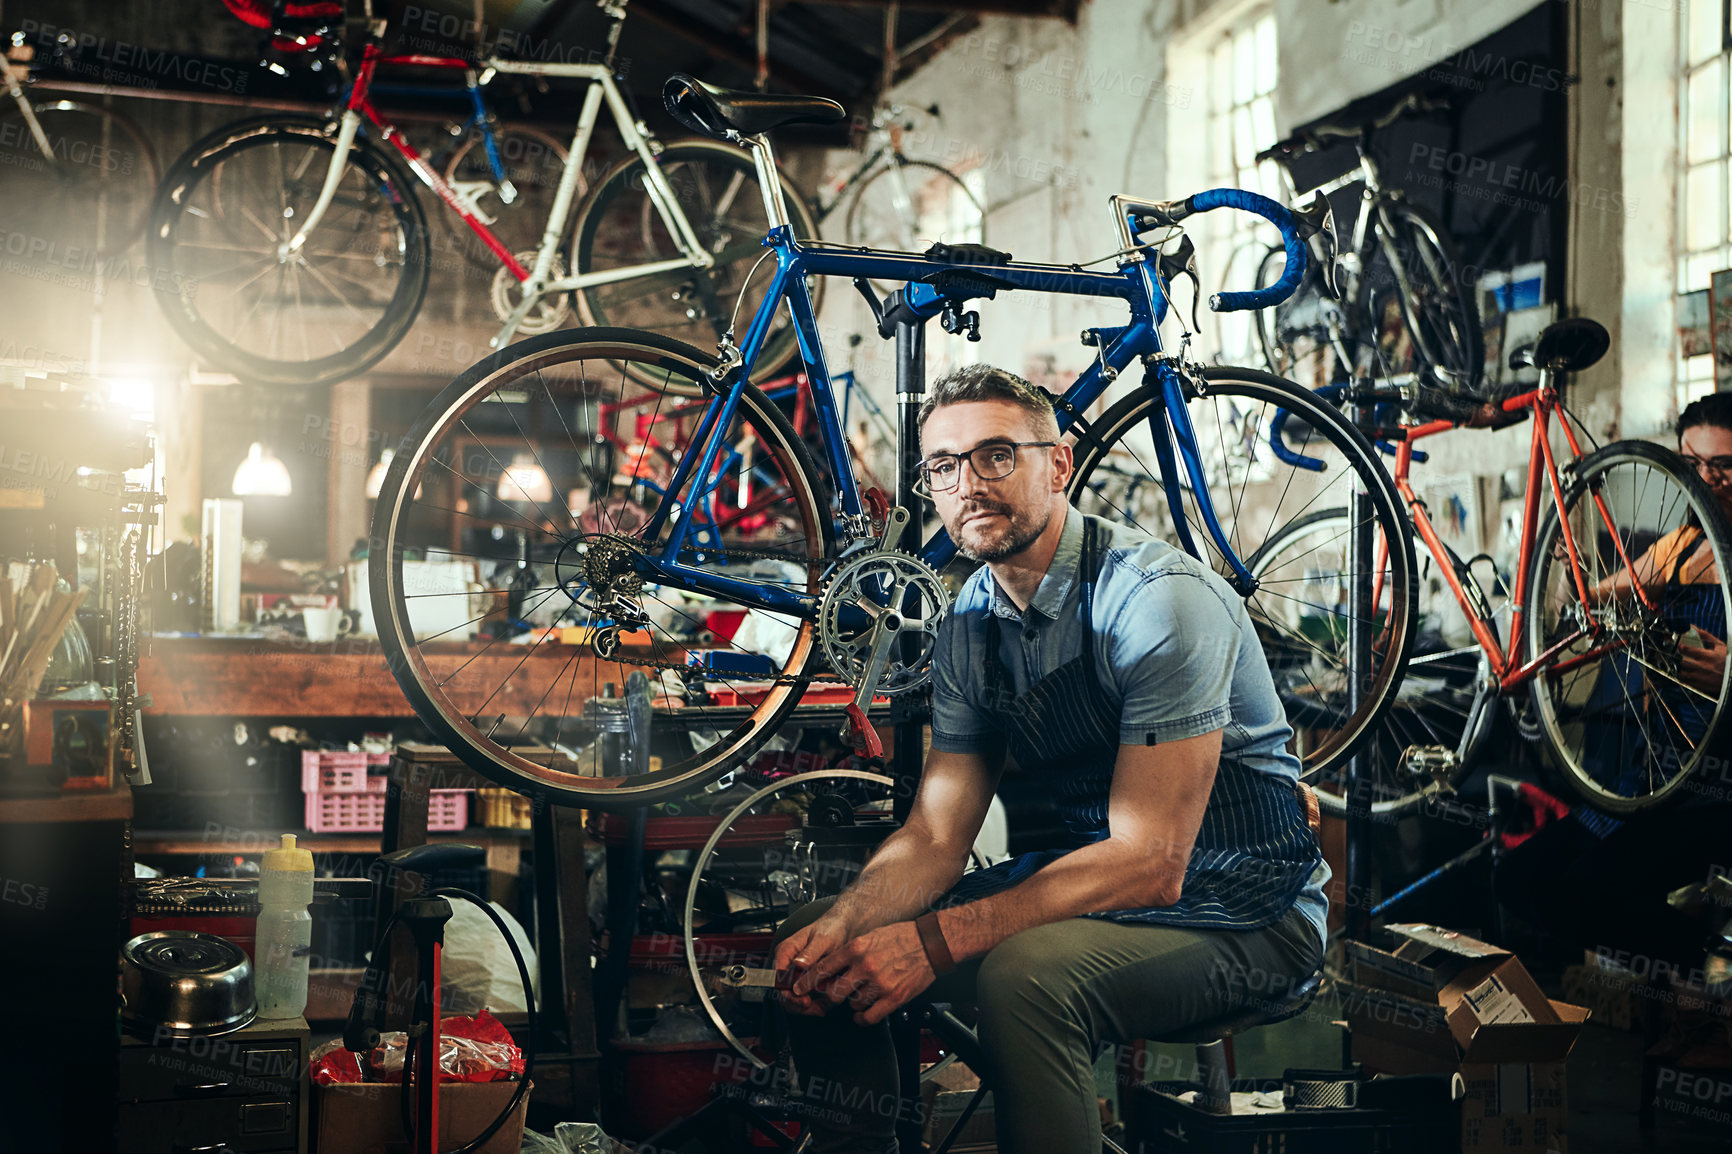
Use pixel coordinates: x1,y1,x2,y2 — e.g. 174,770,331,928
818,549,951,695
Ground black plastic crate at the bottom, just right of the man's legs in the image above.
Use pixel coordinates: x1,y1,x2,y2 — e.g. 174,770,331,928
1126,1081,1462,1154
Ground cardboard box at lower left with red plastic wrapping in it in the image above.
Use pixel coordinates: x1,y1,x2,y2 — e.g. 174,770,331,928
312,1081,535,1154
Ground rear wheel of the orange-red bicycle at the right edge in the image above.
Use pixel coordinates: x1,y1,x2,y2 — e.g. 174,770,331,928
1524,442,1732,816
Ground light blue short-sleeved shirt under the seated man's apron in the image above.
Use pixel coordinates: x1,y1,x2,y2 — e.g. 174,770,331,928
932,509,1330,941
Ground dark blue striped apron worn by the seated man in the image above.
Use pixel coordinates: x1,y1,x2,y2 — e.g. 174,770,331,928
940,525,1322,930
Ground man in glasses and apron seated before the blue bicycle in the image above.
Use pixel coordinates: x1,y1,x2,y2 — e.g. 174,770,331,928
776,366,1328,1154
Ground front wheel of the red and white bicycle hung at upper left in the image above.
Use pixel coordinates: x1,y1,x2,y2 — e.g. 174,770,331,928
145,116,430,385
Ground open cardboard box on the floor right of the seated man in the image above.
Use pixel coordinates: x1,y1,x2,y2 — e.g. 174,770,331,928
1341,925,1590,1154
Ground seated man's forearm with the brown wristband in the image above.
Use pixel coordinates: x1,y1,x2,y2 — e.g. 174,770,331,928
939,839,1188,962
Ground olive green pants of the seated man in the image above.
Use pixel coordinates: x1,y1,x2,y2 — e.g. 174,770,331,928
776,899,1322,1154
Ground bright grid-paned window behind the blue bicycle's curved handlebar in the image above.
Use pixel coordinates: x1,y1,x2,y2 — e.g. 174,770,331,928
1198,9,1283,367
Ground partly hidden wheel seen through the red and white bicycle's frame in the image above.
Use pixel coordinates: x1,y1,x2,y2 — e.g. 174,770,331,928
445,125,587,276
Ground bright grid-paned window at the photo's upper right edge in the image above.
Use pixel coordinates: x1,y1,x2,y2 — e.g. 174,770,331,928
1678,0,1732,409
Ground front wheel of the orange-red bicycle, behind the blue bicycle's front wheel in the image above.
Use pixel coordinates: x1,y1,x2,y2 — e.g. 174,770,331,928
1245,508,1496,820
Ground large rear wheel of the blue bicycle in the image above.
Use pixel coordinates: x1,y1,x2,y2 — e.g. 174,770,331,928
369,329,833,809
